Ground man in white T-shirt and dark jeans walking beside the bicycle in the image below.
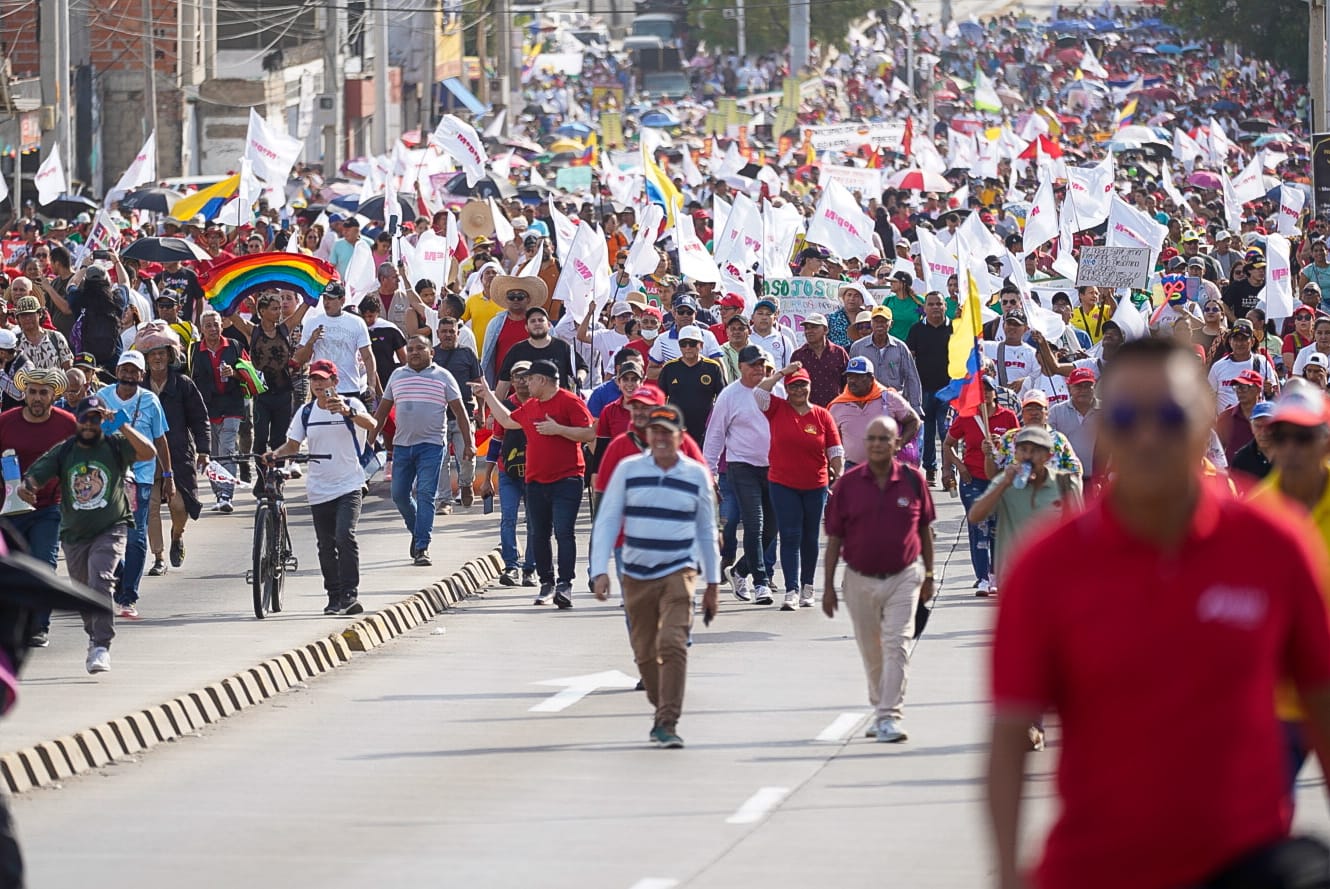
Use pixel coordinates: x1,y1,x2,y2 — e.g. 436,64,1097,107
263,358,375,615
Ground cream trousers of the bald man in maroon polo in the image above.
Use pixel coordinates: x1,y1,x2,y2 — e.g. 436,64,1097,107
845,559,923,721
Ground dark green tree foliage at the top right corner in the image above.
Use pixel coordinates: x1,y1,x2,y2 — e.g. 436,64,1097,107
1164,0,1309,80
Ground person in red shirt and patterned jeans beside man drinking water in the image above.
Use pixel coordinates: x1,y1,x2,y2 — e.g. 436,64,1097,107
942,377,1020,596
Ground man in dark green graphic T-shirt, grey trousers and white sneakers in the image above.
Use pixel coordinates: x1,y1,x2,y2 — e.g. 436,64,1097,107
19,395,157,673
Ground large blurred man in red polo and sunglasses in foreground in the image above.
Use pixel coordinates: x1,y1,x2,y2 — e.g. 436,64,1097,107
988,339,1330,889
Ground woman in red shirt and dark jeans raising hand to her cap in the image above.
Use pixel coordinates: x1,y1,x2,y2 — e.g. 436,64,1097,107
753,362,845,611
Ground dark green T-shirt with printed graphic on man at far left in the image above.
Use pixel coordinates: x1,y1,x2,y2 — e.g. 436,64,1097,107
27,433,134,543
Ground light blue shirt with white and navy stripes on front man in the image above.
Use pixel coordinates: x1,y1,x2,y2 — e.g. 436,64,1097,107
591,454,721,583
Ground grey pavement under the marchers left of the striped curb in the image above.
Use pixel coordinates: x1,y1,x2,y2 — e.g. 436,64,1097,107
0,476,499,752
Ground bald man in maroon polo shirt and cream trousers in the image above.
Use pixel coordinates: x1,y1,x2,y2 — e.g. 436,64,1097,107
822,417,934,743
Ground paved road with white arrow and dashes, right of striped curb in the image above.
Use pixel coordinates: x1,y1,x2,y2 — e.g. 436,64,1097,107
15,500,1330,889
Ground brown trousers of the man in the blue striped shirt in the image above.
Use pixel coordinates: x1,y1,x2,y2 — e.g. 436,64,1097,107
622,568,697,731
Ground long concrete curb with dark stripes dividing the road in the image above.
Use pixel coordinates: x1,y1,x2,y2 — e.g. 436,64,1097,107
0,550,503,793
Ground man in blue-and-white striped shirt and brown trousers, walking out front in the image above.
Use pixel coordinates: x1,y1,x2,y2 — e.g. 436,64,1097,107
591,405,721,748
